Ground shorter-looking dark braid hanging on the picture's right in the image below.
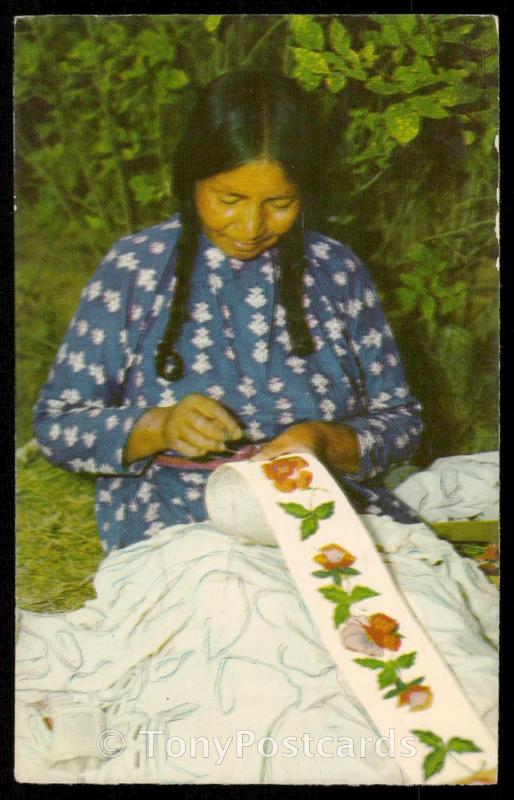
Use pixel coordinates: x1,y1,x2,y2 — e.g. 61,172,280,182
278,223,314,356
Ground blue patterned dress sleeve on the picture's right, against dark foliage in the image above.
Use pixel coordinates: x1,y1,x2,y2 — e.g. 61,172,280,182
336,254,423,481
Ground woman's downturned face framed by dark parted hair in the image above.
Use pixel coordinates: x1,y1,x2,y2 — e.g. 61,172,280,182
195,161,300,261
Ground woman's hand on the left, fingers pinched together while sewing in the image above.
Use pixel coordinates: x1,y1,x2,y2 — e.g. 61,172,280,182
124,394,242,464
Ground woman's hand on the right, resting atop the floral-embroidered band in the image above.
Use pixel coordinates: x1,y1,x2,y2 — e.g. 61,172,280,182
252,422,360,473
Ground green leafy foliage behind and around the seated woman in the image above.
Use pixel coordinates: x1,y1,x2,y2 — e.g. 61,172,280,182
15,14,498,463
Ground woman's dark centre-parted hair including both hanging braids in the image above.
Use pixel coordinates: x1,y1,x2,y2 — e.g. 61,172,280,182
156,70,326,380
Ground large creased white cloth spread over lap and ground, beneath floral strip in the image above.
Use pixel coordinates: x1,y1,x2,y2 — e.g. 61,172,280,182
16,454,498,784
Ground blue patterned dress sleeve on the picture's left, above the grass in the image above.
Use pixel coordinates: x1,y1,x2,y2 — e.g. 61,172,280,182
34,248,152,476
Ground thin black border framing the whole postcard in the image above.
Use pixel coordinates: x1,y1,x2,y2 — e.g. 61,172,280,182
0,0,508,800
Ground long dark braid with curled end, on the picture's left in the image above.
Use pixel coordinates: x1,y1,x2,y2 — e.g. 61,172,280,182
155,209,199,381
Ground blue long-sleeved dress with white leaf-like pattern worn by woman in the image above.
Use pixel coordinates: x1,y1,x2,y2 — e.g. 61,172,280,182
35,215,422,550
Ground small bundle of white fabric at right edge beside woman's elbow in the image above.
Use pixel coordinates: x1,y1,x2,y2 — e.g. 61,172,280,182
394,451,499,522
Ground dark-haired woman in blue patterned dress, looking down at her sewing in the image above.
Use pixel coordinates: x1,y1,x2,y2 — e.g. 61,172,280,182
35,71,422,550
